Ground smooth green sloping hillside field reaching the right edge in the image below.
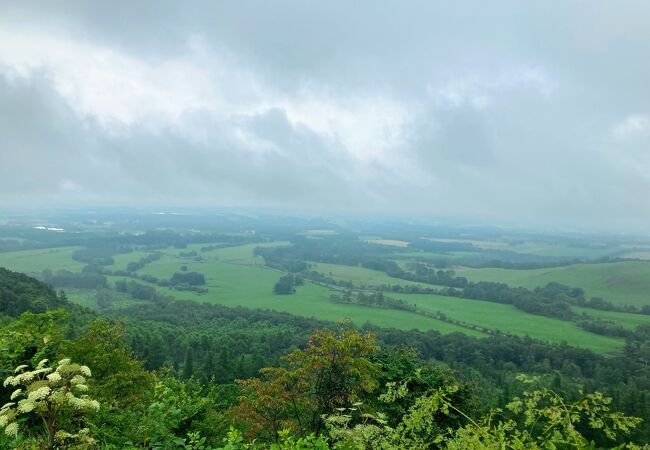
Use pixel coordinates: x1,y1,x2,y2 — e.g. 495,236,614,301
456,261,650,306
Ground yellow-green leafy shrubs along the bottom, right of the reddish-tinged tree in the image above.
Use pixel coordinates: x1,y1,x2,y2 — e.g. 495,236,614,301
326,377,640,450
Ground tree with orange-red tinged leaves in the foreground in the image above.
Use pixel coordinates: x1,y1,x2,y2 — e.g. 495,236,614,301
233,328,378,439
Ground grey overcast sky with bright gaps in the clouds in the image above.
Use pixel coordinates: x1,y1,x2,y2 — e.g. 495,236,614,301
0,0,650,230
